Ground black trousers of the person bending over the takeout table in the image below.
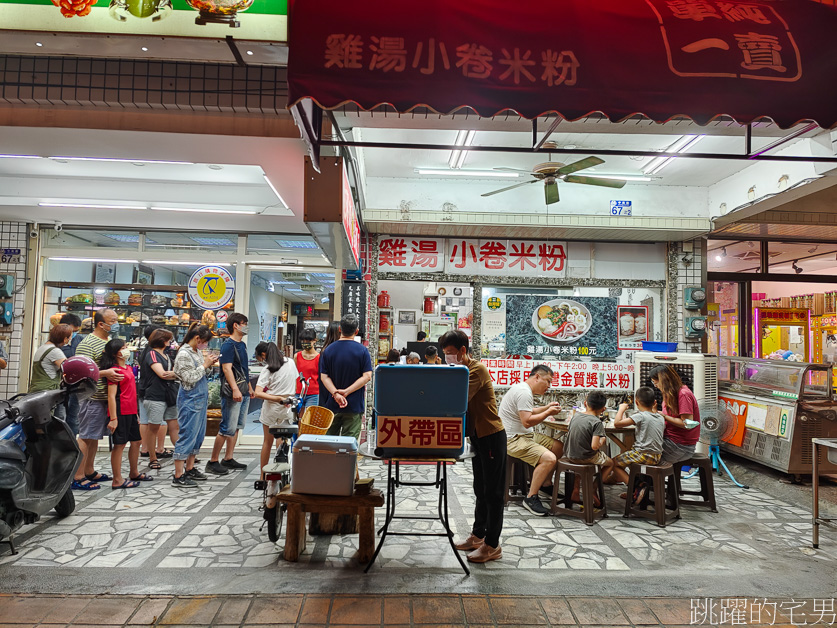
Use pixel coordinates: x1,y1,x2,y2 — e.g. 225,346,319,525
471,430,507,547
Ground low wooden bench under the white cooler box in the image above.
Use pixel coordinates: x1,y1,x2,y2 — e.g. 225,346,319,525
276,488,384,563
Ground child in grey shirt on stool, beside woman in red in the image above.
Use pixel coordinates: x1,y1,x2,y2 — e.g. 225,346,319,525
613,386,666,502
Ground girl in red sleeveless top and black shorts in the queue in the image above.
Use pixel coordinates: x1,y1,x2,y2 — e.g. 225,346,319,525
99,338,154,488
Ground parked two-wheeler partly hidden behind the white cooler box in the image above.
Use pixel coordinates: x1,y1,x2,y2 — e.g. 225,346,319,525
254,375,308,543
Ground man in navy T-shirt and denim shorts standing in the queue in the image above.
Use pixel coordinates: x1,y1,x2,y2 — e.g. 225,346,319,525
206,312,254,475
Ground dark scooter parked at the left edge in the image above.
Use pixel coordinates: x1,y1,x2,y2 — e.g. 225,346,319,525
0,385,84,554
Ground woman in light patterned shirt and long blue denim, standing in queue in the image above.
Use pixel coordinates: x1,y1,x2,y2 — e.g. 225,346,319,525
171,323,218,489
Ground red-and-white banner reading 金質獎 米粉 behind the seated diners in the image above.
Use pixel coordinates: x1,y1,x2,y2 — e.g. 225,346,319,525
480,358,634,390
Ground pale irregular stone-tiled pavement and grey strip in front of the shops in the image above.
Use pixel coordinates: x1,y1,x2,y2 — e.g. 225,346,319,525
0,446,837,600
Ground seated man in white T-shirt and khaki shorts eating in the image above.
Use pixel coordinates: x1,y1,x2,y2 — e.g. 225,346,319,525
498,364,564,517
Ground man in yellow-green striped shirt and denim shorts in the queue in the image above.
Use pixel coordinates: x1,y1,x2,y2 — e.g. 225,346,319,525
72,309,125,491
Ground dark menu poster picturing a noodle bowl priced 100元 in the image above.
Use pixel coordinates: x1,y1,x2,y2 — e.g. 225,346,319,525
505,294,618,358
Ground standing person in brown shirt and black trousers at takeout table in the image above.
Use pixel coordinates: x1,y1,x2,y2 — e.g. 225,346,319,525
439,329,506,563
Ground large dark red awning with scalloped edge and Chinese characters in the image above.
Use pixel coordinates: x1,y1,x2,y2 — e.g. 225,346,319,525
288,0,837,128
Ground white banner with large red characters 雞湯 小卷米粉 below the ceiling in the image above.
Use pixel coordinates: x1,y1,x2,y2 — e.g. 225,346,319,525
378,236,567,278
